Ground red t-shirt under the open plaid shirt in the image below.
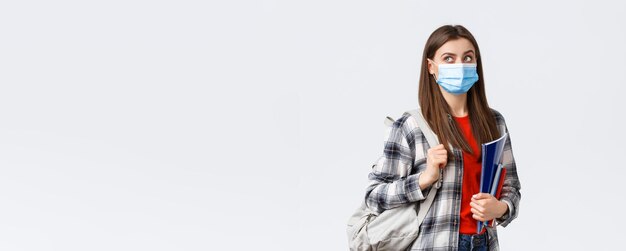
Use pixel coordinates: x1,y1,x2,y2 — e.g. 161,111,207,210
454,116,486,234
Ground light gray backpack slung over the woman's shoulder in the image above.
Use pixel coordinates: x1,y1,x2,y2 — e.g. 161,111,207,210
347,108,443,251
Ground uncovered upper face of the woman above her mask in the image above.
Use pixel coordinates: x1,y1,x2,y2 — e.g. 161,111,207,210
428,38,476,77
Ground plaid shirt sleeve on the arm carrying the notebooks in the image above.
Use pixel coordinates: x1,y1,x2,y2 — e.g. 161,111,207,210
496,112,522,227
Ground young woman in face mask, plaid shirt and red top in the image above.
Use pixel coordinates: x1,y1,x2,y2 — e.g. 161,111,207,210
366,25,521,250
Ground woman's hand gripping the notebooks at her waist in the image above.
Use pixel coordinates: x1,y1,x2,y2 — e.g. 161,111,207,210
470,193,509,221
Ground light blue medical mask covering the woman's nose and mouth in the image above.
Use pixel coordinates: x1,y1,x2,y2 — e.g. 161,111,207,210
428,59,478,95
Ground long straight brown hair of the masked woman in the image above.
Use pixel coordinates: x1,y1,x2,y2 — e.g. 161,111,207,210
419,25,500,155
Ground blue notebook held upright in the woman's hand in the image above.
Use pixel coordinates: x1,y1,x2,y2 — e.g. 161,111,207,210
476,133,507,233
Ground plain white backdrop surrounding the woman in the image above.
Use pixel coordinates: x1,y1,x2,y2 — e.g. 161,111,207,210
0,0,626,251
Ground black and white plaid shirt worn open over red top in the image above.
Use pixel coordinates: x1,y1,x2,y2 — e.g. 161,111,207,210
365,109,521,250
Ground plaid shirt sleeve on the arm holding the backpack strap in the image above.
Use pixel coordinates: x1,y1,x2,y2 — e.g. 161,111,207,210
365,113,427,212
